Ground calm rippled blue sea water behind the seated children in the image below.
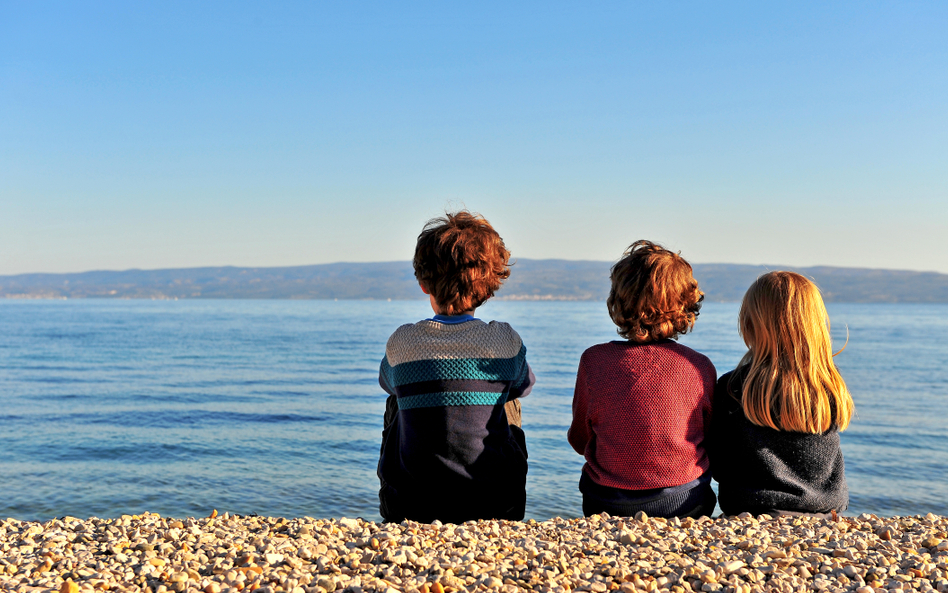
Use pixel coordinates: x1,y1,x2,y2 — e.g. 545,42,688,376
0,300,948,520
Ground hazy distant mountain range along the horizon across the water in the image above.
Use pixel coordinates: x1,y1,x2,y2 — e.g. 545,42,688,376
0,259,948,303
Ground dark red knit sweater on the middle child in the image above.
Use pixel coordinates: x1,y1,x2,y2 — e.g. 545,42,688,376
568,340,717,490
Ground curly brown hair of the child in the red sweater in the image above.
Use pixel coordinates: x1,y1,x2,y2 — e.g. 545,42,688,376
606,240,704,343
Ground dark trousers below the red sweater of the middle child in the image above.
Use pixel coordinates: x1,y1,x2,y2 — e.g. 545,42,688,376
579,472,717,518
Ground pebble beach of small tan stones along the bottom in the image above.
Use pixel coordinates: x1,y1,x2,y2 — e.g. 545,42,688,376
0,511,948,593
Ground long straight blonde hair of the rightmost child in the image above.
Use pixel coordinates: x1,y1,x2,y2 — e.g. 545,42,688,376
738,272,854,434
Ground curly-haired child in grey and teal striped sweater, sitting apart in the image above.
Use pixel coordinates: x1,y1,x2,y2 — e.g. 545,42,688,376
378,211,535,523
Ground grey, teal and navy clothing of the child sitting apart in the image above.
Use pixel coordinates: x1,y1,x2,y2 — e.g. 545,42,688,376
379,315,534,521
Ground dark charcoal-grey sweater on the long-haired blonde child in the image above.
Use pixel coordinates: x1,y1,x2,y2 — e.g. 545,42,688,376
707,368,849,515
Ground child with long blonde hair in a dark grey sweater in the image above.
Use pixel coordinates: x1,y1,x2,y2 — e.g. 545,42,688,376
710,272,853,515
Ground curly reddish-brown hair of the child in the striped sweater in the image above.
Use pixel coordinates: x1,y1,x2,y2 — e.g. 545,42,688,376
412,210,510,315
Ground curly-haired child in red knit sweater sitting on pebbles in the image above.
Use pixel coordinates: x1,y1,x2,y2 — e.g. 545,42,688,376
568,241,716,517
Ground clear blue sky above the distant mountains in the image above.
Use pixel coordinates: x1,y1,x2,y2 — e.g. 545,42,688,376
0,0,948,274
